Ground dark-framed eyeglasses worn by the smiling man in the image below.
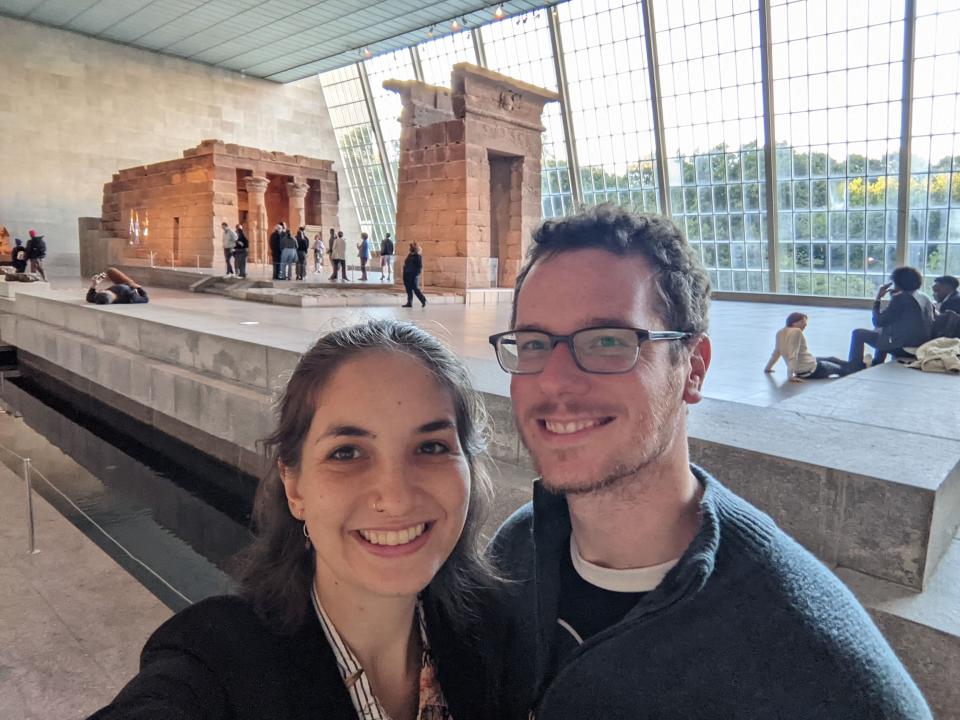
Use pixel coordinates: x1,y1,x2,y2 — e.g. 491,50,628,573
490,327,693,375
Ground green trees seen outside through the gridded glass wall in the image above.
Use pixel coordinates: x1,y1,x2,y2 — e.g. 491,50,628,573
543,142,960,297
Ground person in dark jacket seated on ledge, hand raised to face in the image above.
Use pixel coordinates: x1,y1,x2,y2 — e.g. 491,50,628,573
847,267,933,372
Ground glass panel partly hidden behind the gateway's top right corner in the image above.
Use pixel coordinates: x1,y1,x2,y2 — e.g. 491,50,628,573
480,10,574,217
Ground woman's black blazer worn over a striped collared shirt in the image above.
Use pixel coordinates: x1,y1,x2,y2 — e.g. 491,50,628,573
91,596,498,720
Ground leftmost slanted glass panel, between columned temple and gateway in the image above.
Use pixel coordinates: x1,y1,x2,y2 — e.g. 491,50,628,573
320,65,396,238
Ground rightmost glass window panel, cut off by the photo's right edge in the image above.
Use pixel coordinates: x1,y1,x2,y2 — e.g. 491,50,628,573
907,0,960,288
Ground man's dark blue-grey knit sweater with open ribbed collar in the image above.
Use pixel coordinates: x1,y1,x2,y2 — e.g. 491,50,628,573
490,467,931,720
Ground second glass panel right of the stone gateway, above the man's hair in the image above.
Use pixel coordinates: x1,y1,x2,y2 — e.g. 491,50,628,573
557,0,659,212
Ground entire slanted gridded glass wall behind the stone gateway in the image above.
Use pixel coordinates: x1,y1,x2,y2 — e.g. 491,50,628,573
322,0,960,297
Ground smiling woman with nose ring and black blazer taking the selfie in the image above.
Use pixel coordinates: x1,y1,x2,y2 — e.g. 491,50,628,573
86,321,496,720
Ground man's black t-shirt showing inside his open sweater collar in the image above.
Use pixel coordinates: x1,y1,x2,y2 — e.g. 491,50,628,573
553,552,646,669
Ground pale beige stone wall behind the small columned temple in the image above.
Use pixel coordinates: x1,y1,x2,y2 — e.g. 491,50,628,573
0,17,360,273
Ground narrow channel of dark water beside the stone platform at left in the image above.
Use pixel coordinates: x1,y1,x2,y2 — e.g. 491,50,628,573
0,362,256,610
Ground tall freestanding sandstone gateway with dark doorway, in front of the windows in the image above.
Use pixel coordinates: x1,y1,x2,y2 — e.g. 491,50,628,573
384,63,557,288
